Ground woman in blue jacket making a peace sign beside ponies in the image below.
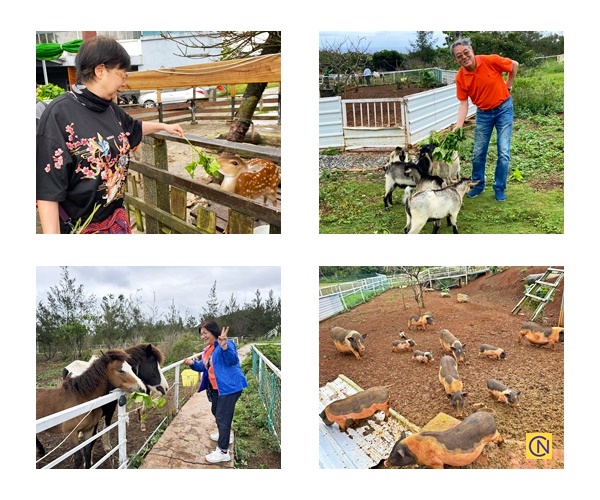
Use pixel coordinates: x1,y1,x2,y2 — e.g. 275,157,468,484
183,321,248,463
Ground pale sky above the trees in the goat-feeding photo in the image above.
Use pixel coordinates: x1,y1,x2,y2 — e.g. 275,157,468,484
319,31,445,54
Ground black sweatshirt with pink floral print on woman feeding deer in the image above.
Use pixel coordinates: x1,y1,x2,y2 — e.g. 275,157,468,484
36,86,142,229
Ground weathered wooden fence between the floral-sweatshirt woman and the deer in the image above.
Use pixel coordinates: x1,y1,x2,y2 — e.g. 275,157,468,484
125,132,281,234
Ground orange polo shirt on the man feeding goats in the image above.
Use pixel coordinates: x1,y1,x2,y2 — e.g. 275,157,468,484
456,54,512,110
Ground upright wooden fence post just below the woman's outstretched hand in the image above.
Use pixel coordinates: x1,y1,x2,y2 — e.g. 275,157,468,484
142,136,171,234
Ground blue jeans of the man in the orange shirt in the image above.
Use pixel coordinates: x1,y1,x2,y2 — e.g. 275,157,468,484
471,97,514,193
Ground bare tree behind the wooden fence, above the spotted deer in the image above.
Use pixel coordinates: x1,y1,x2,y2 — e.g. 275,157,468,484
161,31,281,142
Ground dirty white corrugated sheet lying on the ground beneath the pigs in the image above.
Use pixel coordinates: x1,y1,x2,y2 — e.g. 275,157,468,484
319,375,419,469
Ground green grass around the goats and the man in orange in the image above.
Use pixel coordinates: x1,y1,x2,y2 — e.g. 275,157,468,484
319,64,564,234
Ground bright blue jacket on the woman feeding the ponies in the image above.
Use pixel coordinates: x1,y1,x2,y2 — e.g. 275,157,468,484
190,340,248,396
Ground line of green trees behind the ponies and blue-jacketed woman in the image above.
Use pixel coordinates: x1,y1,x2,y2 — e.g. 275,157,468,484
36,267,281,359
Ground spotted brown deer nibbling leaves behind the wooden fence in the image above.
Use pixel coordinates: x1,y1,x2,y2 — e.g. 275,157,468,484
217,153,281,206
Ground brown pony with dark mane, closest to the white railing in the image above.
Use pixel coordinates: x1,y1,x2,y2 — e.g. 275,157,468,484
36,349,144,469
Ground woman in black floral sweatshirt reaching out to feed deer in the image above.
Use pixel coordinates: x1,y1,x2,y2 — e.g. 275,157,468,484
36,36,183,234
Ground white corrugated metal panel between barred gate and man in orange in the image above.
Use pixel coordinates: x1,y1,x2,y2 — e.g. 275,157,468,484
406,85,477,144
